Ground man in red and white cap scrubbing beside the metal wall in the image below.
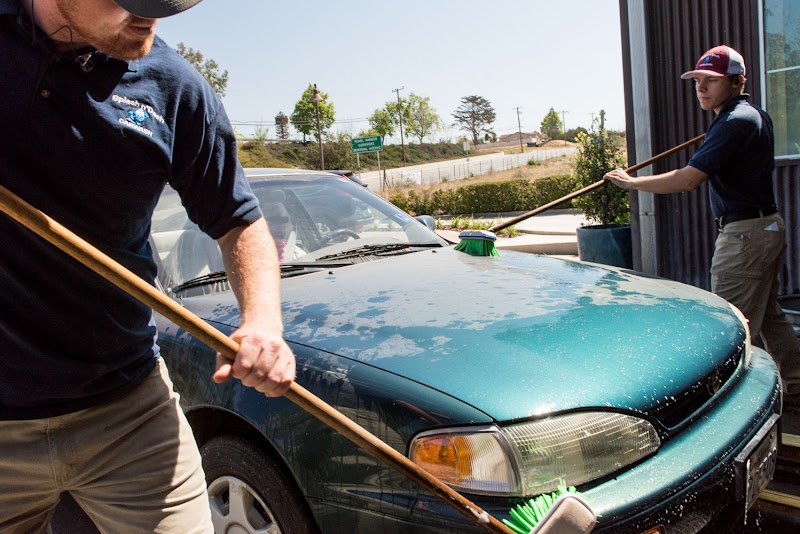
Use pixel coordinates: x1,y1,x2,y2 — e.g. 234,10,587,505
605,45,800,408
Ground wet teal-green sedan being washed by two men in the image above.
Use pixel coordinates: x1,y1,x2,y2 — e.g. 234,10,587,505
151,169,781,534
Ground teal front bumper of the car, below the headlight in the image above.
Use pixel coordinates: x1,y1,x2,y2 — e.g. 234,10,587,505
412,347,781,534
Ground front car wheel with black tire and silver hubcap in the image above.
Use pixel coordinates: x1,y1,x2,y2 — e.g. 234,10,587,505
200,436,319,534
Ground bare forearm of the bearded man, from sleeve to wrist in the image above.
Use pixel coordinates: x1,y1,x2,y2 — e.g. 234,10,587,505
219,219,283,332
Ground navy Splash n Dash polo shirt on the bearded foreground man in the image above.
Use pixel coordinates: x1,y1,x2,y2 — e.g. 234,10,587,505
0,0,261,419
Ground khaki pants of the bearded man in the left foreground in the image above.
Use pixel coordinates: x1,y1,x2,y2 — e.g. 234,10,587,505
0,359,213,534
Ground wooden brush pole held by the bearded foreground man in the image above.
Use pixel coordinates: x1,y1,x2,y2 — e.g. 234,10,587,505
0,186,513,534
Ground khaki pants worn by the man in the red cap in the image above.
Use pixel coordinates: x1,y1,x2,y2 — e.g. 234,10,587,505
711,213,800,393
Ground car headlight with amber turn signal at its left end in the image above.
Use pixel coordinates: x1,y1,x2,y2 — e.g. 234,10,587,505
410,412,661,496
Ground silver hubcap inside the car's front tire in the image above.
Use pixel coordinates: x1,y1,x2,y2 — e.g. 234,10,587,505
208,477,281,534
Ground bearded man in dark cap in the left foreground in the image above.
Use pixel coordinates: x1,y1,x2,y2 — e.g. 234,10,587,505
0,0,295,534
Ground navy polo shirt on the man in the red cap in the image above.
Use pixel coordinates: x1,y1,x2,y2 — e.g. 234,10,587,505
688,94,775,218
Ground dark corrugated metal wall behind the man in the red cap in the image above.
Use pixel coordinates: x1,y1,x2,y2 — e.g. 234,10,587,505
620,0,800,293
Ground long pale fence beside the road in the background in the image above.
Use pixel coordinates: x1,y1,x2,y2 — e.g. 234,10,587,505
360,147,577,189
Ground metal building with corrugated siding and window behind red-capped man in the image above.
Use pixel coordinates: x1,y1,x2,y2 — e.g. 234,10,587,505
620,0,800,294
